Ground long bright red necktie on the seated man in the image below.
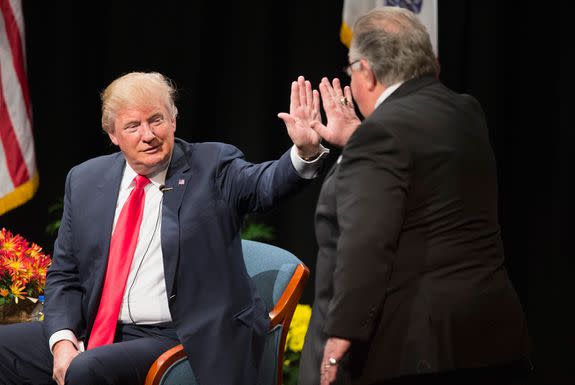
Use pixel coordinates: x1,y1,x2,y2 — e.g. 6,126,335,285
88,175,150,349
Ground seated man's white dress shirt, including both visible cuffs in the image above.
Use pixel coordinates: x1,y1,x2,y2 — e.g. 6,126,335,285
49,146,329,351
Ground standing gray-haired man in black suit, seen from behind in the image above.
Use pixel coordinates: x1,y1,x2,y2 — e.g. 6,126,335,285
290,7,530,385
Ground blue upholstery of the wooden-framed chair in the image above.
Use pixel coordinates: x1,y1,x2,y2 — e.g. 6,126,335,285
155,240,301,385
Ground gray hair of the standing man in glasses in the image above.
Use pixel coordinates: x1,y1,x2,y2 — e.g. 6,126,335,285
349,7,439,85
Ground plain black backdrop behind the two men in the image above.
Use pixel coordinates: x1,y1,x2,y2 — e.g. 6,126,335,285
0,0,575,384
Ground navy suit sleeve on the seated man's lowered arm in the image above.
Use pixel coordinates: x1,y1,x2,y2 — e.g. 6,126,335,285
44,170,83,336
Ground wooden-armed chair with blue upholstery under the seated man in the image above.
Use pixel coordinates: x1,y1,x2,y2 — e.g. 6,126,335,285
145,240,309,385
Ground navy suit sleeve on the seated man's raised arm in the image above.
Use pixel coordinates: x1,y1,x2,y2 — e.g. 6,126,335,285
217,145,309,214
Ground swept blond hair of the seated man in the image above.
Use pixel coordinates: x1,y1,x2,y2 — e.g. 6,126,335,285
100,72,178,132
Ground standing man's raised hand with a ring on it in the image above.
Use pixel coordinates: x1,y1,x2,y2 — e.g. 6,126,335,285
312,78,361,147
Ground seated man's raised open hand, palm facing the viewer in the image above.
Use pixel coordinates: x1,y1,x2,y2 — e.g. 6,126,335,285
278,76,321,159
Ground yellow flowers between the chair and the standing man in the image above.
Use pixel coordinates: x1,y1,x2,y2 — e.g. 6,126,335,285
283,304,311,385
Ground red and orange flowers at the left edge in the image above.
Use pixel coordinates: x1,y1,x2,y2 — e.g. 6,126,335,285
0,228,52,305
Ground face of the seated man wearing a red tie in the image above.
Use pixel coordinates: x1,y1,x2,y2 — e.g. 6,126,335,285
108,103,176,175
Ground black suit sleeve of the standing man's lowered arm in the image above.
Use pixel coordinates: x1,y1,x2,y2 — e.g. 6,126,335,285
325,118,409,341
